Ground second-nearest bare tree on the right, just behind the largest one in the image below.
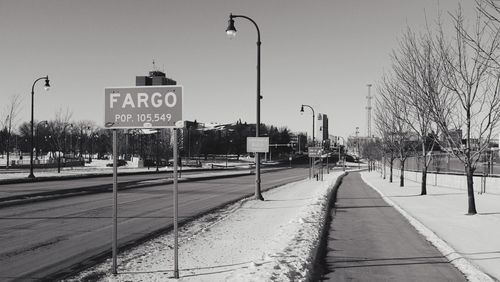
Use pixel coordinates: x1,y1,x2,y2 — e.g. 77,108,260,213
392,28,444,195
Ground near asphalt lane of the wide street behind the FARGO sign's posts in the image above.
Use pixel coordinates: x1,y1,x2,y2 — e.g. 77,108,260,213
0,168,308,281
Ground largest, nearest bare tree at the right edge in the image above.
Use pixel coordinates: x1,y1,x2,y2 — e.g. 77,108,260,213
428,8,500,215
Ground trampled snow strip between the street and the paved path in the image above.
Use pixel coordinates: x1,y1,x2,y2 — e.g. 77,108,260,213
68,172,341,281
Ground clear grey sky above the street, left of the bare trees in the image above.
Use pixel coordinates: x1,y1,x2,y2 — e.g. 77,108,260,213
0,0,474,139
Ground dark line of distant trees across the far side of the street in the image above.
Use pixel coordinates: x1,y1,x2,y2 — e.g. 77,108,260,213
0,110,307,163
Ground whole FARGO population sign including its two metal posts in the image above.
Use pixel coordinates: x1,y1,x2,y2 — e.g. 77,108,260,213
104,85,183,278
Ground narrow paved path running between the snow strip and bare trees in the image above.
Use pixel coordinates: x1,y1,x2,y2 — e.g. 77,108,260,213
320,173,466,281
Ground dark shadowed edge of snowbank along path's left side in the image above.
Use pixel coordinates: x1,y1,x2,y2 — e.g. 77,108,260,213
306,171,349,281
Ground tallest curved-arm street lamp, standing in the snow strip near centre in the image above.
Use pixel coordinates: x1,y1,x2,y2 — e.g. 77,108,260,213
226,14,264,201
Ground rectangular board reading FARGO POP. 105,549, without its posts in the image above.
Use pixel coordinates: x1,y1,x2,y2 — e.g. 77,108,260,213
104,85,183,128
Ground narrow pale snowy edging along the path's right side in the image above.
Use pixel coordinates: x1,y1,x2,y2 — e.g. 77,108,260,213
361,174,498,282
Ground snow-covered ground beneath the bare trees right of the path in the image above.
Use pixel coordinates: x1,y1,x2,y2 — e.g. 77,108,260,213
361,172,500,281
